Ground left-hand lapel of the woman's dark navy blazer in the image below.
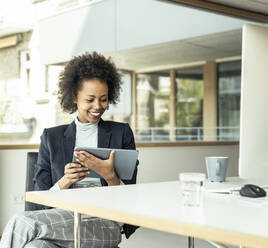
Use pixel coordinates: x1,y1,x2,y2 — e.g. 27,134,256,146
63,121,76,164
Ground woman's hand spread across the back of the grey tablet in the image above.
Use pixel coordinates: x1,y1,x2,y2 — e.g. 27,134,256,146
74,151,120,185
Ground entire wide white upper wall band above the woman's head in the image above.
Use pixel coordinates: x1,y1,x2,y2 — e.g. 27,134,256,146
38,0,245,64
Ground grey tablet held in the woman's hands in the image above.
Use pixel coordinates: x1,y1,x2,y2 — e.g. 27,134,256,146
73,147,138,180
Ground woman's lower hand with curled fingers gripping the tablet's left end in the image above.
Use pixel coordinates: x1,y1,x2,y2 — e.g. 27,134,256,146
58,163,90,189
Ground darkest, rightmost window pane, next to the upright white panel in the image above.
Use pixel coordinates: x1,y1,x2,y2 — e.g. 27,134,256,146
218,61,241,141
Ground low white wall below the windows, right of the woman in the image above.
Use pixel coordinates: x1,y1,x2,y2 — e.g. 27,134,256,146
138,145,239,183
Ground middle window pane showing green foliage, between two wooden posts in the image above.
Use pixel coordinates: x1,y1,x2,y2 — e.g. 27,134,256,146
176,67,203,140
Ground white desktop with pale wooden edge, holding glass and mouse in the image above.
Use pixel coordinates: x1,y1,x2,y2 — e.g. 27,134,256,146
26,178,268,248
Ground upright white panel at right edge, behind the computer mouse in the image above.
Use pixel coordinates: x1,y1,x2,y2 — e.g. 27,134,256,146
239,25,268,178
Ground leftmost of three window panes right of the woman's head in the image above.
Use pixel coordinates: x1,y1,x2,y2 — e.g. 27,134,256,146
136,71,170,142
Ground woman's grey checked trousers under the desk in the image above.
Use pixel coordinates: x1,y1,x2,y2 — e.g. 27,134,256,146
0,209,121,248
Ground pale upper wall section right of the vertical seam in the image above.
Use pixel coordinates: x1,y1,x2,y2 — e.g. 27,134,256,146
116,0,245,50
